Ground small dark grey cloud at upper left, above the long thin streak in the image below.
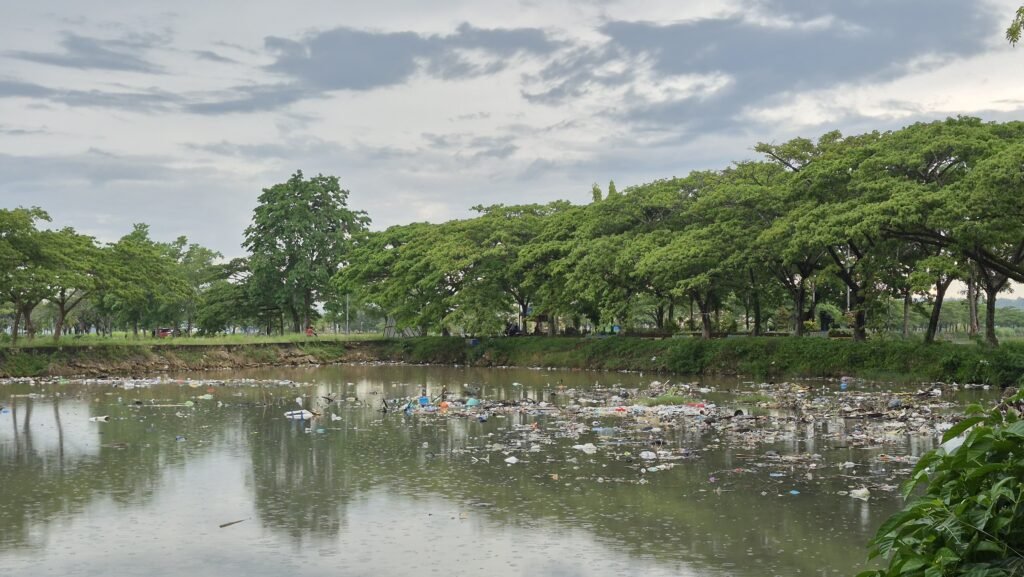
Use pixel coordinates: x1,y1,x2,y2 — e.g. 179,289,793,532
7,32,167,73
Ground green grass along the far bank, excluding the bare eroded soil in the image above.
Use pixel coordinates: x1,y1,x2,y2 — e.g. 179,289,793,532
0,334,1024,386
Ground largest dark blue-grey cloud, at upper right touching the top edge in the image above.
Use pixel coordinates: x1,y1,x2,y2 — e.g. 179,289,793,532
523,0,998,130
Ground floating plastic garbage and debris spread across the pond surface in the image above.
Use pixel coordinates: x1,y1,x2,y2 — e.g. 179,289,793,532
0,377,982,506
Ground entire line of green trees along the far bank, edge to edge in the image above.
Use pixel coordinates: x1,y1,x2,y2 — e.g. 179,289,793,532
0,118,1024,343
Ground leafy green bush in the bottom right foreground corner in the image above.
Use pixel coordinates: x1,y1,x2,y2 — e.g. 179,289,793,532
858,393,1024,577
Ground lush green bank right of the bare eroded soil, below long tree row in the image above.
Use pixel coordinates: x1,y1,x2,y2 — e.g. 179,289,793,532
370,337,1024,385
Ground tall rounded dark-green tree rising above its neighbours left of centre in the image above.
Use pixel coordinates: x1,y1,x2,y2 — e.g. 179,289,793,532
243,170,370,332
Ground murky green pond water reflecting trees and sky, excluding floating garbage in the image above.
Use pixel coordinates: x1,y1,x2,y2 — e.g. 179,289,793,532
0,367,995,577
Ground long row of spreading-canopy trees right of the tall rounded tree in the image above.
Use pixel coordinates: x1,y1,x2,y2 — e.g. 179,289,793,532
335,118,1024,343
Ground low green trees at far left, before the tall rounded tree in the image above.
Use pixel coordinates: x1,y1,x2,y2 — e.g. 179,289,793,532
0,208,220,342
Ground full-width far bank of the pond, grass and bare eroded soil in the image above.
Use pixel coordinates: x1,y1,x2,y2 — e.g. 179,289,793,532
0,337,1024,385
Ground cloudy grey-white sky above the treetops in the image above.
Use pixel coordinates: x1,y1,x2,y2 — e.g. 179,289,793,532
0,0,1024,256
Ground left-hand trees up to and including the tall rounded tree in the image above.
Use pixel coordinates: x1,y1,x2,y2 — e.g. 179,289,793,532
0,172,369,342
